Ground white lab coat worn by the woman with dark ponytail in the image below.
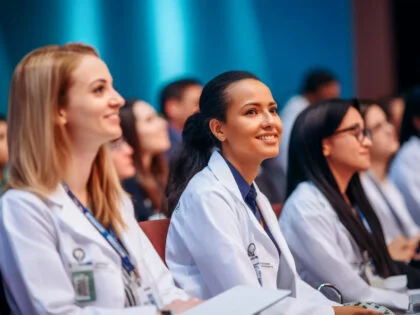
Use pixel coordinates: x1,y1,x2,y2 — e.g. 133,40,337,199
166,152,338,315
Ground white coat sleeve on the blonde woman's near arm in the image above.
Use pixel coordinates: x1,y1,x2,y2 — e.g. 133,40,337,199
0,192,157,315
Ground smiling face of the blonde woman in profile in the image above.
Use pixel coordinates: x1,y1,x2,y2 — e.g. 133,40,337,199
60,55,124,146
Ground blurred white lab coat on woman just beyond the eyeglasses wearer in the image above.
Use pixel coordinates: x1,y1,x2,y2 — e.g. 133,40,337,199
360,172,420,244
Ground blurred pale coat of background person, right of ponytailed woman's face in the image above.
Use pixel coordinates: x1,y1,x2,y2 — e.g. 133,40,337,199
277,95,309,174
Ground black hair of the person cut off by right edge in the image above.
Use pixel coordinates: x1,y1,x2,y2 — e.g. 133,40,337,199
400,86,420,145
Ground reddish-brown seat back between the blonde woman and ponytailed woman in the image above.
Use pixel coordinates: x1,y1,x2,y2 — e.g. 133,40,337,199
139,219,170,265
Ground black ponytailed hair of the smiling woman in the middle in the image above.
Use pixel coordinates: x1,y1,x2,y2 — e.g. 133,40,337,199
166,71,259,213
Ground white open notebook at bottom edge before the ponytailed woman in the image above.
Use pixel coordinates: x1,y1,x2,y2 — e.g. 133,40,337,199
183,286,290,315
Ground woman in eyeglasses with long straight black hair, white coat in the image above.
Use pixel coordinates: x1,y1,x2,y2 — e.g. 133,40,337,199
280,100,418,310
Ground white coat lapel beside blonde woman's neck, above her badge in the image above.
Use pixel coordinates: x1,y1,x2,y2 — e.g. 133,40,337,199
46,185,117,255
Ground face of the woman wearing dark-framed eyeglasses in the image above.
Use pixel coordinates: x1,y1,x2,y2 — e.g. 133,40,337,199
322,106,372,176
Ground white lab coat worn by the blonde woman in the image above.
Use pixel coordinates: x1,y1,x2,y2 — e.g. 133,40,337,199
0,185,188,315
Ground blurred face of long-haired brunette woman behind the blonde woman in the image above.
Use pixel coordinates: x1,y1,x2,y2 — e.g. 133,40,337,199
133,101,171,155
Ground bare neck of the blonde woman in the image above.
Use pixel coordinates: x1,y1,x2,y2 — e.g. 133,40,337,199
63,146,99,206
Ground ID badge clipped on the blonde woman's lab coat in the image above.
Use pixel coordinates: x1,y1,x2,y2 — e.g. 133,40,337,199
70,264,96,303
